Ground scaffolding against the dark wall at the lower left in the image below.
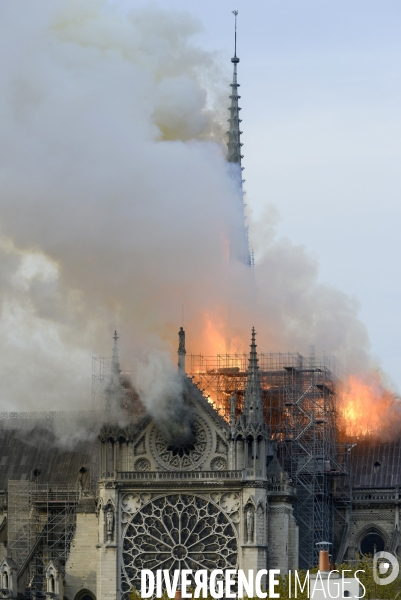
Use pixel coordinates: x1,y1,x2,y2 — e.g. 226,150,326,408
8,480,79,598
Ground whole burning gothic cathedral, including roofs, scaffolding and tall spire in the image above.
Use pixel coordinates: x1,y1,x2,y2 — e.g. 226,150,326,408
0,16,401,600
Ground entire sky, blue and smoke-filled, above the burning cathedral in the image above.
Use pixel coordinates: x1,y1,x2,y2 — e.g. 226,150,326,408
0,0,401,410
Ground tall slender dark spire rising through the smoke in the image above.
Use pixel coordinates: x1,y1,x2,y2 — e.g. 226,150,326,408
227,10,252,266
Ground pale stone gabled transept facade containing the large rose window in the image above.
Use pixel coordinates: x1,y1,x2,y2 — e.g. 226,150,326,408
97,360,297,599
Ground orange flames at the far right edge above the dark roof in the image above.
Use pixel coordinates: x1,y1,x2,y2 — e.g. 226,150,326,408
339,373,401,439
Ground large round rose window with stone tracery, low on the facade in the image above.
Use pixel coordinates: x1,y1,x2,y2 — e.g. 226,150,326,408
122,494,237,597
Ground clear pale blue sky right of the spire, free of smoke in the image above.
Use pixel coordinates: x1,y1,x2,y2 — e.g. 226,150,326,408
121,0,401,388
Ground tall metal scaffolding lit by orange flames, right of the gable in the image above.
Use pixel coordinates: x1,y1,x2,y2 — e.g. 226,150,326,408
188,351,346,568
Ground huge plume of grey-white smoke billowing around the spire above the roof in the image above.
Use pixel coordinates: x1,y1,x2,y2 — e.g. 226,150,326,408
0,0,382,428
